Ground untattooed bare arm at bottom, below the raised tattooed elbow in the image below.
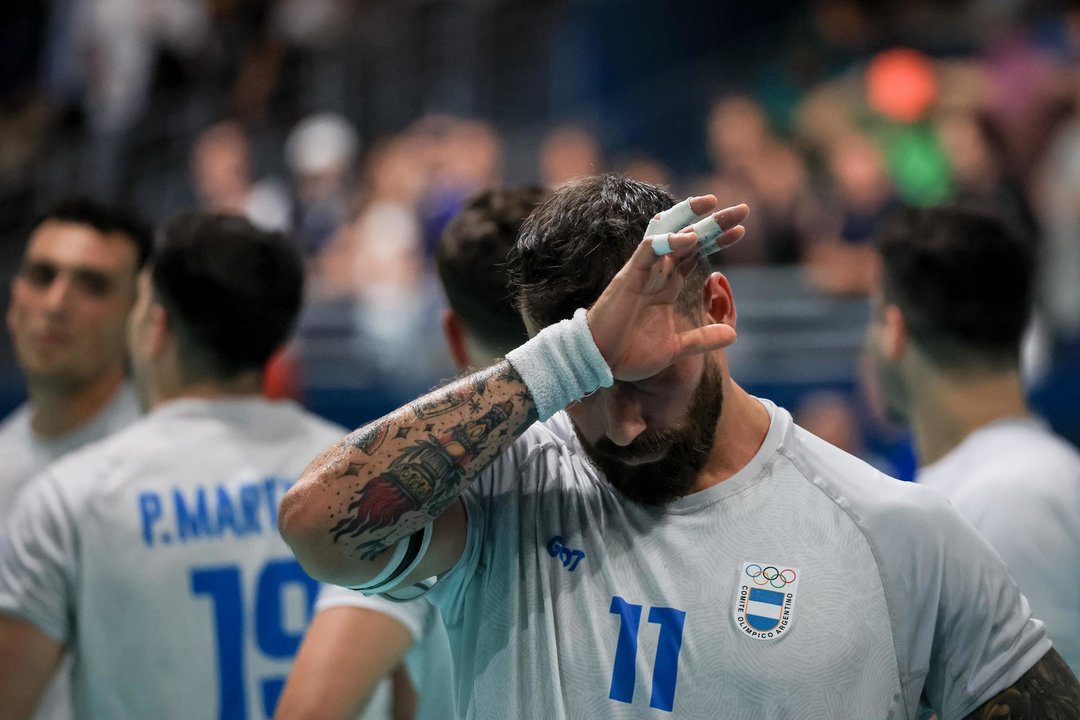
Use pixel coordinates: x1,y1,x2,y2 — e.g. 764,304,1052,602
274,607,413,720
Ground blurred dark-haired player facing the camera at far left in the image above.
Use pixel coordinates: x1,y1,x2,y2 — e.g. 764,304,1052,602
0,198,151,509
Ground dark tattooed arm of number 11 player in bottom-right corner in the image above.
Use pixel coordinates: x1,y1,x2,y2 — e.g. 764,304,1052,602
967,650,1080,720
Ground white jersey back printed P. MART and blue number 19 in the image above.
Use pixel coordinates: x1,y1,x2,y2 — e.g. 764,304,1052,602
0,398,343,720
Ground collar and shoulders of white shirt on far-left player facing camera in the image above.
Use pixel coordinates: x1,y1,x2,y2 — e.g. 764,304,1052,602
0,384,139,511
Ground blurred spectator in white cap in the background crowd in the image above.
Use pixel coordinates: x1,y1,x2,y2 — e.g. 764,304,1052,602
285,112,360,259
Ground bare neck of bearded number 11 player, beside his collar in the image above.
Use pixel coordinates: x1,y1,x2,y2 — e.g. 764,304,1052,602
691,377,769,492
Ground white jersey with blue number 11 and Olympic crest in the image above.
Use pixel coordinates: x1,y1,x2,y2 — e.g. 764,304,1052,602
431,403,1050,720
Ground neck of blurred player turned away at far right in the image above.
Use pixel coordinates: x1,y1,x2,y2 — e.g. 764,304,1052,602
912,371,1029,465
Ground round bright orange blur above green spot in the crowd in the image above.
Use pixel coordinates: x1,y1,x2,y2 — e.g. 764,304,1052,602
866,47,937,122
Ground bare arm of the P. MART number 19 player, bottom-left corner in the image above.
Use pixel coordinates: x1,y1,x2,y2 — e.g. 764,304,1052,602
0,615,64,720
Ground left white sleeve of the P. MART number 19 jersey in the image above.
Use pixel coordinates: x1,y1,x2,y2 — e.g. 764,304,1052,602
0,471,77,644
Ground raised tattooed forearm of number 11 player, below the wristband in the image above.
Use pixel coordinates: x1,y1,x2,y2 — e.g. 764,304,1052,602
280,362,536,585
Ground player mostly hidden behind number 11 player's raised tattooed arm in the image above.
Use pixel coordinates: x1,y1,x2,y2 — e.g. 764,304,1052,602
279,186,548,720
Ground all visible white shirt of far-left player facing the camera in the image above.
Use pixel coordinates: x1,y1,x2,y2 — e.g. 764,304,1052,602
0,383,141,720
